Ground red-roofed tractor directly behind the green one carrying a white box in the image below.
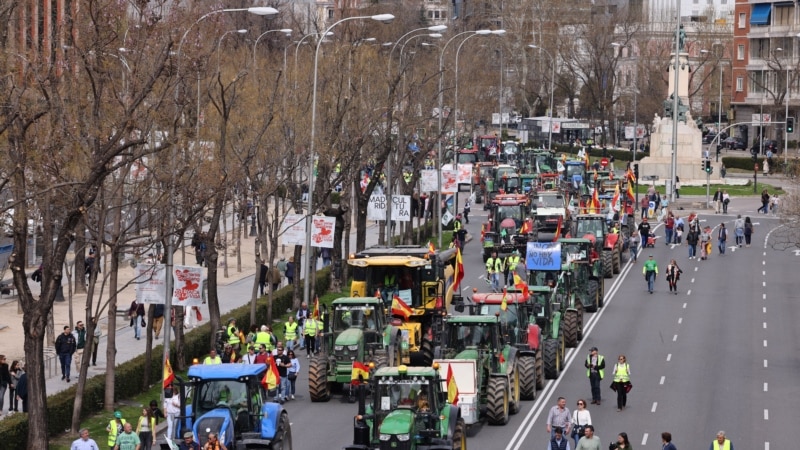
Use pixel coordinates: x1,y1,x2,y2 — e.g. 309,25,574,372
455,289,544,400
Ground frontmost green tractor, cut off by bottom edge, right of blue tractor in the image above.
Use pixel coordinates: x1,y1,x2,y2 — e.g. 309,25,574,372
345,364,467,450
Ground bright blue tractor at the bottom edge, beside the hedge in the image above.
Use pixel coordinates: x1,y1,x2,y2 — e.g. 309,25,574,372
162,364,292,450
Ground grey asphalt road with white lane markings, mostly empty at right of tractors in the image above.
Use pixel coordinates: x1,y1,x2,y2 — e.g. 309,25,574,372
286,205,800,450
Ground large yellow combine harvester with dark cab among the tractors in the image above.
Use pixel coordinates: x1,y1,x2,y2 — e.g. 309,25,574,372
347,245,456,366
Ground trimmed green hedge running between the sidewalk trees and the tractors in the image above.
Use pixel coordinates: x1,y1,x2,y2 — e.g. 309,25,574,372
0,268,330,450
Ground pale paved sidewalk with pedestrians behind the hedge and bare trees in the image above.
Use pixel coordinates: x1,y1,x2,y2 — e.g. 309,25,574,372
0,216,390,417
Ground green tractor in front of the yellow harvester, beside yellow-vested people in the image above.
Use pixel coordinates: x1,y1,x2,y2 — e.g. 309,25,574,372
308,297,403,402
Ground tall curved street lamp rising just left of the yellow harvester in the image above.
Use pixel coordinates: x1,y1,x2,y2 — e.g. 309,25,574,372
298,14,394,303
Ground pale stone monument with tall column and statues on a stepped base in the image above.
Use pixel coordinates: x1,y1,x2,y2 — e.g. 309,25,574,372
639,26,719,184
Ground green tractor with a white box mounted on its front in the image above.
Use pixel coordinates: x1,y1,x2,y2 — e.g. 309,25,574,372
434,316,521,425
